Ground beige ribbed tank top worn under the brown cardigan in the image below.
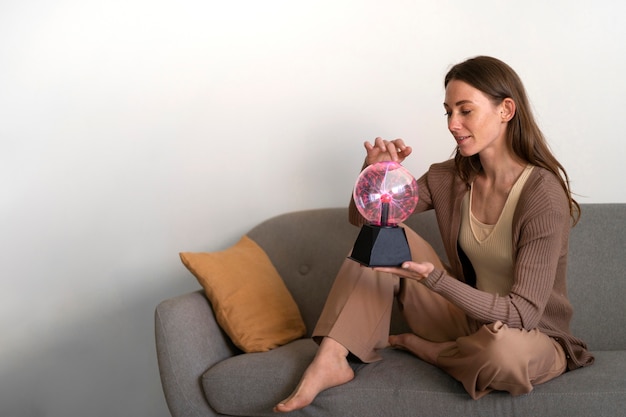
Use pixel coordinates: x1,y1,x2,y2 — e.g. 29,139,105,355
459,165,533,296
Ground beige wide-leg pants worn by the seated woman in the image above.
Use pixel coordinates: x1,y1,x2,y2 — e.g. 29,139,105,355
313,227,567,399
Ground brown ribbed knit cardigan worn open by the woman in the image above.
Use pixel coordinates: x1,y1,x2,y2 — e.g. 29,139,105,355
350,160,593,369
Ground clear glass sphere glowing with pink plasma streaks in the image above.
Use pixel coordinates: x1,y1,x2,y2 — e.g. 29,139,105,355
353,161,419,226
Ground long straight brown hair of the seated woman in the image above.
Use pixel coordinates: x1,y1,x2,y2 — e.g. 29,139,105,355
444,56,580,224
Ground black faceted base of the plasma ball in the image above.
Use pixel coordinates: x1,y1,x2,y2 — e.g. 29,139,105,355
349,225,411,267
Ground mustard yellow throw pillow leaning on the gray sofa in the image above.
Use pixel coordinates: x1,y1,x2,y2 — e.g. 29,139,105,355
180,236,306,352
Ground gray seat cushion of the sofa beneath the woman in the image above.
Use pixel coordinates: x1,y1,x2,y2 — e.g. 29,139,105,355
202,339,626,417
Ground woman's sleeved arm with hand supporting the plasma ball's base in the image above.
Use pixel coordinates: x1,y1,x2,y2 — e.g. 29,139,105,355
378,176,570,329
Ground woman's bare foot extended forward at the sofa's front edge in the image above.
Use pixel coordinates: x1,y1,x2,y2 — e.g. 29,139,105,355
274,337,354,413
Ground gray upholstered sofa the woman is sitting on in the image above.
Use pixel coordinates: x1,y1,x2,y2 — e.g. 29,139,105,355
155,204,626,417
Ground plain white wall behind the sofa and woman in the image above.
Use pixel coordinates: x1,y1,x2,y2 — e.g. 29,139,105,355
0,0,626,417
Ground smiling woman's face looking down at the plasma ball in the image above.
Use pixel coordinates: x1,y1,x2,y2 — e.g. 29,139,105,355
443,80,512,156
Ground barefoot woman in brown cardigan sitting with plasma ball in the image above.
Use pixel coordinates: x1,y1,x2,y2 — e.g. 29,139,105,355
275,56,593,412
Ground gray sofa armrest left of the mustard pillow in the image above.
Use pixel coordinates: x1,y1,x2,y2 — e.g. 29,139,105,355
155,291,236,417
